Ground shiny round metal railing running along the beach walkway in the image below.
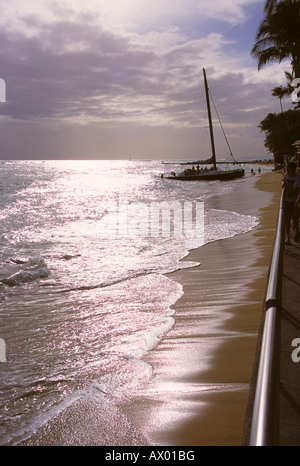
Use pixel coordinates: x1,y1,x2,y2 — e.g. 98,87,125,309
249,190,285,446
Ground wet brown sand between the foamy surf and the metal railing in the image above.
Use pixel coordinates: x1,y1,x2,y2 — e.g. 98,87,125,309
123,172,281,446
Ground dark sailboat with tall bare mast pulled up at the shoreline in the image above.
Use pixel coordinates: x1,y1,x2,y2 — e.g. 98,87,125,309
166,68,245,181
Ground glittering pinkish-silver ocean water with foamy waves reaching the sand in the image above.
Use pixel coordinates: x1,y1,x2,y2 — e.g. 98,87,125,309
0,160,270,445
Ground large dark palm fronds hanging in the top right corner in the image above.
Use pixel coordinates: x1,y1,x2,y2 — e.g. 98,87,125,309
251,0,300,78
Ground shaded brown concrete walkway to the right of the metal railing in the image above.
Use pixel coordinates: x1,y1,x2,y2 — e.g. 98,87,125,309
279,241,300,446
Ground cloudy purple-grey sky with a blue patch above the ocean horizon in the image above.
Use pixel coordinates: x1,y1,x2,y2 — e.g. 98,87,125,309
0,0,293,160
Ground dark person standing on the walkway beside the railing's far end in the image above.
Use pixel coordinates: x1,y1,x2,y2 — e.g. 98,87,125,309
282,162,300,246
